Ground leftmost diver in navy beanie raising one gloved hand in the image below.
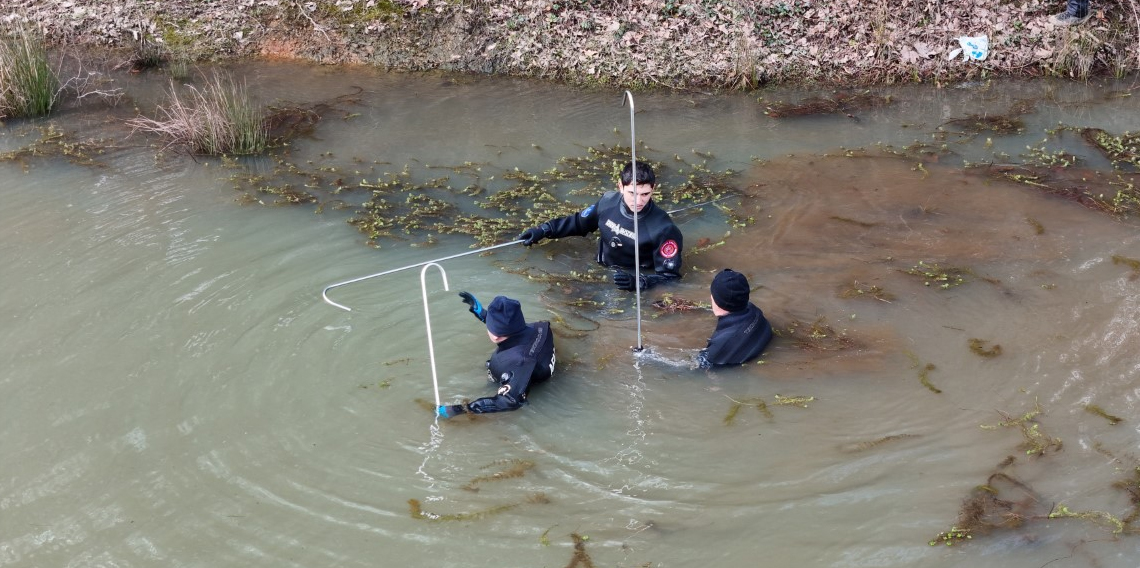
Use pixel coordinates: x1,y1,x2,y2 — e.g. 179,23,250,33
435,292,554,419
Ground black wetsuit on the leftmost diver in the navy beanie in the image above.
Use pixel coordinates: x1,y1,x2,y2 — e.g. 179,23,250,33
448,322,554,415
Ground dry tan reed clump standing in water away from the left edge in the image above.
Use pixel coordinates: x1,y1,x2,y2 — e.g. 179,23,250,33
128,73,269,155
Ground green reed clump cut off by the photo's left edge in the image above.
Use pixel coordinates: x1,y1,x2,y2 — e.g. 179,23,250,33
0,24,59,117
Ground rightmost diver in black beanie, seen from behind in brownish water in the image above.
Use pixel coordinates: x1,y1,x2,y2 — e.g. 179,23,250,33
697,268,772,368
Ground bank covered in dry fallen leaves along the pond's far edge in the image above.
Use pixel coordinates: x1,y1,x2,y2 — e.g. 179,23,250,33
17,0,1140,90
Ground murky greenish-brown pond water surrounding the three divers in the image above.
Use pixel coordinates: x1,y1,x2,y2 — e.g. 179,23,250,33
0,65,1140,567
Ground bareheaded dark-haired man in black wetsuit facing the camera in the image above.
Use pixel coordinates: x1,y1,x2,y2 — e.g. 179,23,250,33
519,162,683,290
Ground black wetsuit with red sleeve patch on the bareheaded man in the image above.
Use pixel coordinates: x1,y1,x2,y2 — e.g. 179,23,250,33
542,192,683,287
